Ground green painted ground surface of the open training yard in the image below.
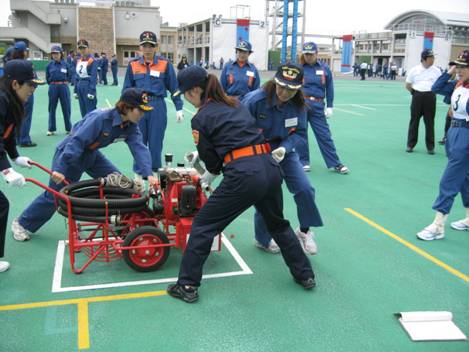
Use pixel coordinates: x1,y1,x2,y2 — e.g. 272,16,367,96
0,80,469,352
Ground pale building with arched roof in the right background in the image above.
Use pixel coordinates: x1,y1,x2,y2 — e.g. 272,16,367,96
354,10,469,71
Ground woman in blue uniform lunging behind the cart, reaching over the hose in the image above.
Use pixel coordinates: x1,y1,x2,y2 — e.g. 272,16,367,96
12,89,156,241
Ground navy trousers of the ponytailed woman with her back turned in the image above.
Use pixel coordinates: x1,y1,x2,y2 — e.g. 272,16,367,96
178,154,314,286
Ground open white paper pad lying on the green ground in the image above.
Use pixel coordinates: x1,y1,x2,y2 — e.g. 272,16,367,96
397,311,467,341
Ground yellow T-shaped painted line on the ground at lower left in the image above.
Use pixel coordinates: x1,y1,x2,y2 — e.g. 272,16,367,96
0,290,167,350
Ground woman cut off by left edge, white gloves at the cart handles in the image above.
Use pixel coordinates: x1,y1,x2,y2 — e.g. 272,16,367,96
0,60,44,272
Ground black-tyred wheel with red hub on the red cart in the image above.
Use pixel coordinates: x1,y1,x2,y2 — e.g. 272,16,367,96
123,226,170,272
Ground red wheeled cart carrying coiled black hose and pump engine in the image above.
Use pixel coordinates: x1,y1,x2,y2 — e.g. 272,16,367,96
26,162,221,274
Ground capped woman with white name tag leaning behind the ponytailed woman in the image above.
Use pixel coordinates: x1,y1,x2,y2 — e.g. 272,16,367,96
242,64,323,254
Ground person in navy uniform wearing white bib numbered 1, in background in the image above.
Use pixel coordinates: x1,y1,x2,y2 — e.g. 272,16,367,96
74,39,98,117
